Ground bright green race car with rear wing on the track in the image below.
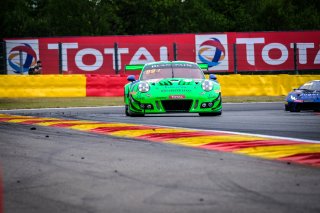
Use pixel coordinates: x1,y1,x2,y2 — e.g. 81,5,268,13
124,61,222,116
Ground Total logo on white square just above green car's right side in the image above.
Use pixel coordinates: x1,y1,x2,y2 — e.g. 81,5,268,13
195,35,229,70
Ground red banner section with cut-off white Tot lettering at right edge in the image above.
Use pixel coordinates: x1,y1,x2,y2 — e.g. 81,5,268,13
228,31,320,71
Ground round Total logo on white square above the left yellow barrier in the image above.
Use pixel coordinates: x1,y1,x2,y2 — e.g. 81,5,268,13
7,40,38,74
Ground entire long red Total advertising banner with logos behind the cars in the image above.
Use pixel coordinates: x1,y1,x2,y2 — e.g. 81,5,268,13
5,31,320,75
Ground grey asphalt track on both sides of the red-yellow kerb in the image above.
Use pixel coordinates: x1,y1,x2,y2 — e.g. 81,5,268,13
0,103,320,212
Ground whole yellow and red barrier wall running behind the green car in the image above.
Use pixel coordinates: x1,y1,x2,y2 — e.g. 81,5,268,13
0,75,320,97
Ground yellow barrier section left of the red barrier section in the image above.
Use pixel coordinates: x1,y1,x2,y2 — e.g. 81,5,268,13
0,75,86,98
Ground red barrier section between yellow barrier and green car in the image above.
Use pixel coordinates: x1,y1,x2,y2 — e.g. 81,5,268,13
86,75,128,97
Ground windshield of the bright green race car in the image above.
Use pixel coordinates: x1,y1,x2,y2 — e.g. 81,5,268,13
140,63,204,80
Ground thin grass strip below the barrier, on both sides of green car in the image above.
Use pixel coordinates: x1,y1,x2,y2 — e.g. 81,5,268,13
0,96,284,109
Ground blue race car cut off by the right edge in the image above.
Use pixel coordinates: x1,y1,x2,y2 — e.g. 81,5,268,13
285,80,320,112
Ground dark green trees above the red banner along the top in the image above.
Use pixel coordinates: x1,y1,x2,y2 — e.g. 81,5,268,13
0,0,320,38
